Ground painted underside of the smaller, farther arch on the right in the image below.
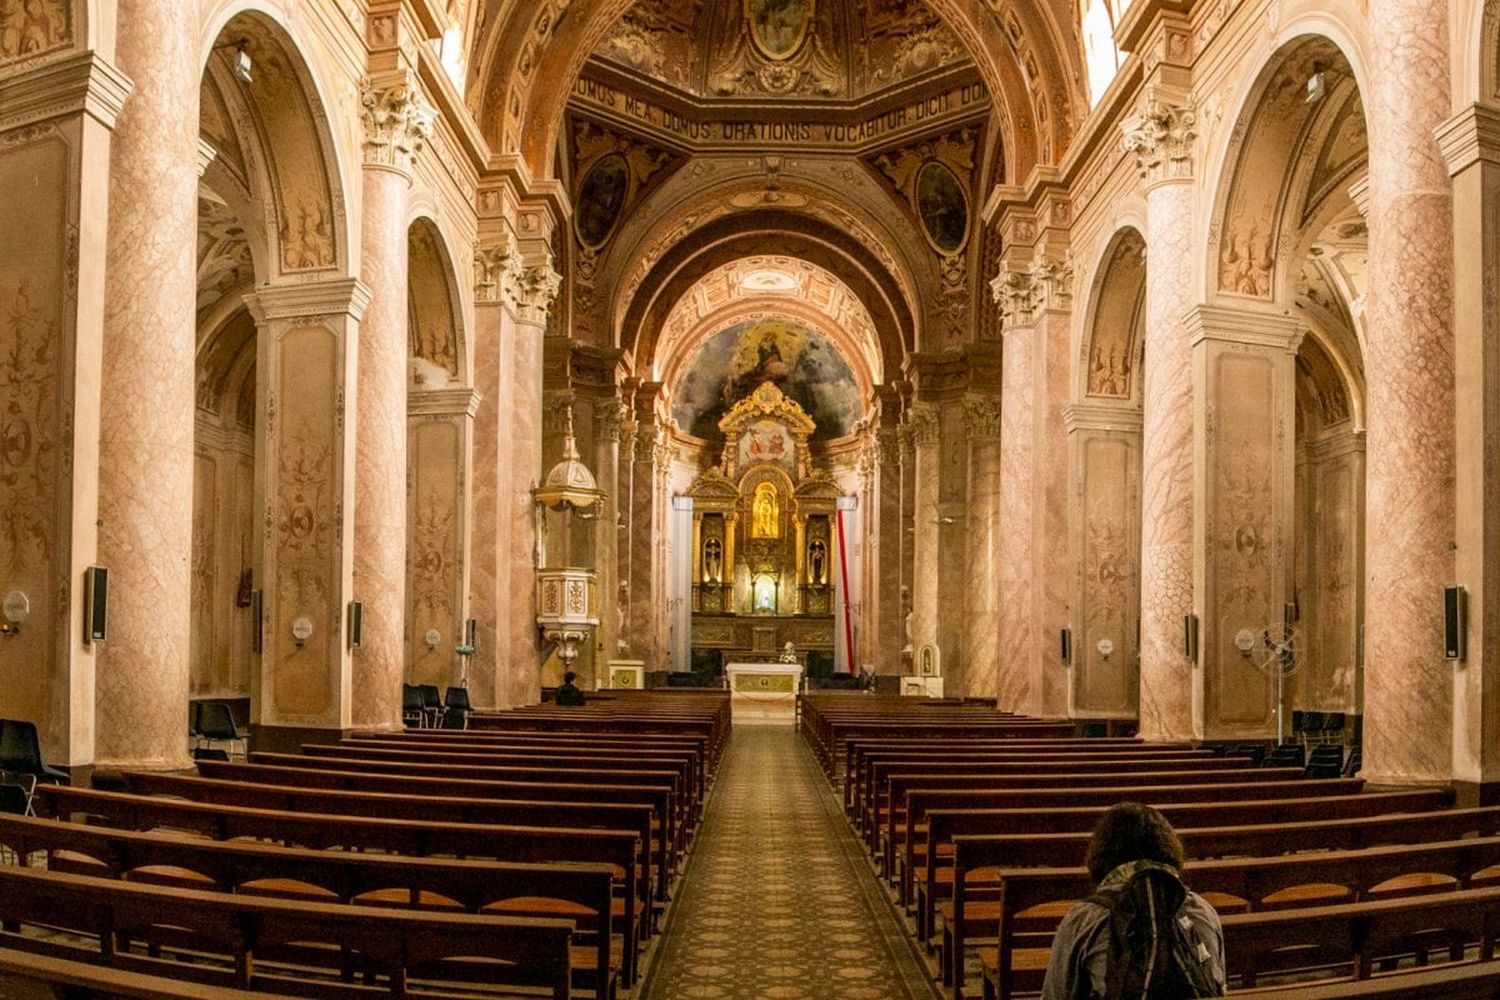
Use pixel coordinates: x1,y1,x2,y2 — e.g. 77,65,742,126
1074,225,1146,406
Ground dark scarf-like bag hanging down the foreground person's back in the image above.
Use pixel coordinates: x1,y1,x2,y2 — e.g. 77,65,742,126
1089,865,1224,1000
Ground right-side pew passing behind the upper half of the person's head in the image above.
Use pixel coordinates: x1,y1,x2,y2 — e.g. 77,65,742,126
938,807,1500,997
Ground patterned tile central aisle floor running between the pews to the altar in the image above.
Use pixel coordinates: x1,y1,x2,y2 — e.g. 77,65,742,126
642,726,938,1000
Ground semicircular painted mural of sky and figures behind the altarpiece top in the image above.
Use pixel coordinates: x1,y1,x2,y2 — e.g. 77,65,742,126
672,319,860,441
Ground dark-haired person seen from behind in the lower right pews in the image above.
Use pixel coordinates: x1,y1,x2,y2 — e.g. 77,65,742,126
1041,802,1226,1000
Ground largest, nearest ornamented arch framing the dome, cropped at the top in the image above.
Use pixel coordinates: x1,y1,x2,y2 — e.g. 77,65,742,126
473,0,1089,183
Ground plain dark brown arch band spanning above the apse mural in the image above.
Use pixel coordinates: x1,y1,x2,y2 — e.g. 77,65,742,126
617,210,915,380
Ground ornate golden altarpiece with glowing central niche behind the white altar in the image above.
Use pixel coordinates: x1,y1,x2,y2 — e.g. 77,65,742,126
687,382,839,663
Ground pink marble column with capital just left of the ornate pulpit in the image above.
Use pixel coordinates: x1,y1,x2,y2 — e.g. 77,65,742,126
501,255,563,705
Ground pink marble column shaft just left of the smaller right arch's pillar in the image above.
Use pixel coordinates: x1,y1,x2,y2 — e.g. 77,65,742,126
995,327,1041,715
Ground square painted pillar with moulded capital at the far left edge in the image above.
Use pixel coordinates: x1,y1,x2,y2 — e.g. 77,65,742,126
0,50,130,765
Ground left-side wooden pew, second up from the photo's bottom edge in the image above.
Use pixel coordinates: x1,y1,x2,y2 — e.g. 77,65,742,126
0,868,573,1000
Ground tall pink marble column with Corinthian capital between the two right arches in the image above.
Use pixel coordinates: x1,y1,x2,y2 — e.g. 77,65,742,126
1122,90,1197,739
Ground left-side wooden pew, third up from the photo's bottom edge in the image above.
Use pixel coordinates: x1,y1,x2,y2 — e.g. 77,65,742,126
0,816,621,1000
